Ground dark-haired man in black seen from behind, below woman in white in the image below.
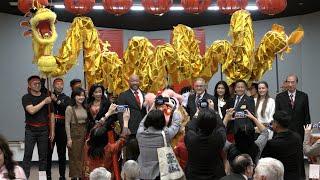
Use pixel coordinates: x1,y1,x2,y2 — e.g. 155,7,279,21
261,111,305,180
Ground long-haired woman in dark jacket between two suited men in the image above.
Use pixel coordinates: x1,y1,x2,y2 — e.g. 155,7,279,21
214,81,230,119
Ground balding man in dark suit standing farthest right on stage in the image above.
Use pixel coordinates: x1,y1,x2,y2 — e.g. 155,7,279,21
276,75,310,142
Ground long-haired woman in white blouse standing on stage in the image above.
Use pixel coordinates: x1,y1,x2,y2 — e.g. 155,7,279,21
254,81,275,126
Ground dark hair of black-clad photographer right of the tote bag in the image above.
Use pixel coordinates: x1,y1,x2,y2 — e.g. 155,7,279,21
197,108,217,135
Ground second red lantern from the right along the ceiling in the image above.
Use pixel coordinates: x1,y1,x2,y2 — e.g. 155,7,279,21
217,0,248,14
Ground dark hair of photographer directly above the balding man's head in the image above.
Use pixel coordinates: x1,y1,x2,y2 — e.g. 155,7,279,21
228,127,260,162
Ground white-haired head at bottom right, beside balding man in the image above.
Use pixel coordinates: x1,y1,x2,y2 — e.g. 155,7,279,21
255,158,284,180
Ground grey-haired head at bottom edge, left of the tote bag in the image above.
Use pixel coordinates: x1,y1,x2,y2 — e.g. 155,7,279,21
121,160,140,180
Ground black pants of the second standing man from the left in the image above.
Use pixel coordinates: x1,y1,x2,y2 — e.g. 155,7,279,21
47,120,67,177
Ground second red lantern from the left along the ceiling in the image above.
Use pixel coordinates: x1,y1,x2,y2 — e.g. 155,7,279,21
64,0,96,15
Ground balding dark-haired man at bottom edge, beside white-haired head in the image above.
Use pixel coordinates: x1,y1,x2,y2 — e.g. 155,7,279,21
220,154,254,180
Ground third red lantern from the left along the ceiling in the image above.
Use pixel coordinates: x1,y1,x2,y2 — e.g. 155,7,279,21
102,0,133,15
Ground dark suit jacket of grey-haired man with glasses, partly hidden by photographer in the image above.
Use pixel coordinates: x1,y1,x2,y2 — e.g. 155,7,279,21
186,92,218,118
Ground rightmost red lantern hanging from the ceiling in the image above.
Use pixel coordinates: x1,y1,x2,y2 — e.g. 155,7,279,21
256,0,287,15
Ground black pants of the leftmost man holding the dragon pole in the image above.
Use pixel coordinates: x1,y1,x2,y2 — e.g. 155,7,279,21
22,127,49,178
